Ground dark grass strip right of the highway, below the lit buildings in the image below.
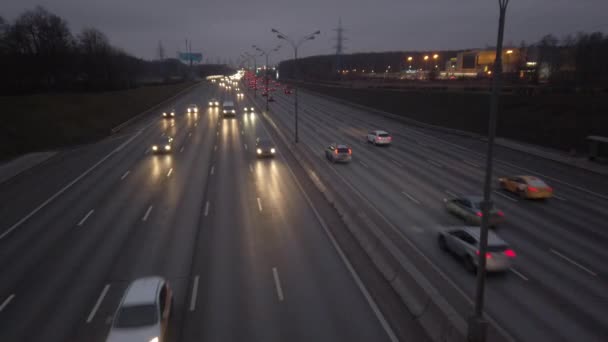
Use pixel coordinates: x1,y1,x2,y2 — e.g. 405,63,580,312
296,84,608,153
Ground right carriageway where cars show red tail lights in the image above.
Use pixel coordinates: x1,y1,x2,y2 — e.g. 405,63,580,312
262,83,608,341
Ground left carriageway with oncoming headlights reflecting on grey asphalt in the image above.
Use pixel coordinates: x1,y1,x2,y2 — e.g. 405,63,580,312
0,84,404,342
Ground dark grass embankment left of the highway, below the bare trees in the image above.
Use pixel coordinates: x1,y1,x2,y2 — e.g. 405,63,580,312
0,82,193,160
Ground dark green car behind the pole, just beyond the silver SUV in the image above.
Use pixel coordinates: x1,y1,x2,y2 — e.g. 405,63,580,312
443,196,505,227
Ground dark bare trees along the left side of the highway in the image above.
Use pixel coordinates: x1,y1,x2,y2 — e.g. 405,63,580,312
0,7,186,94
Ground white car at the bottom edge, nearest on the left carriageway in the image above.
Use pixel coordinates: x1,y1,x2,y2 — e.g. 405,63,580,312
106,276,173,342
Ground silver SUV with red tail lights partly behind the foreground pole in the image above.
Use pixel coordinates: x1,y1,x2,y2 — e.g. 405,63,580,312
438,226,516,273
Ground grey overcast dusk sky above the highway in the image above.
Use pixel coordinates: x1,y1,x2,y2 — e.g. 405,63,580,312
0,0,608,62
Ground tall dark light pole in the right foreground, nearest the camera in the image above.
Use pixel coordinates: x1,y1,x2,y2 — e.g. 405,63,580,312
468,0,509,342
